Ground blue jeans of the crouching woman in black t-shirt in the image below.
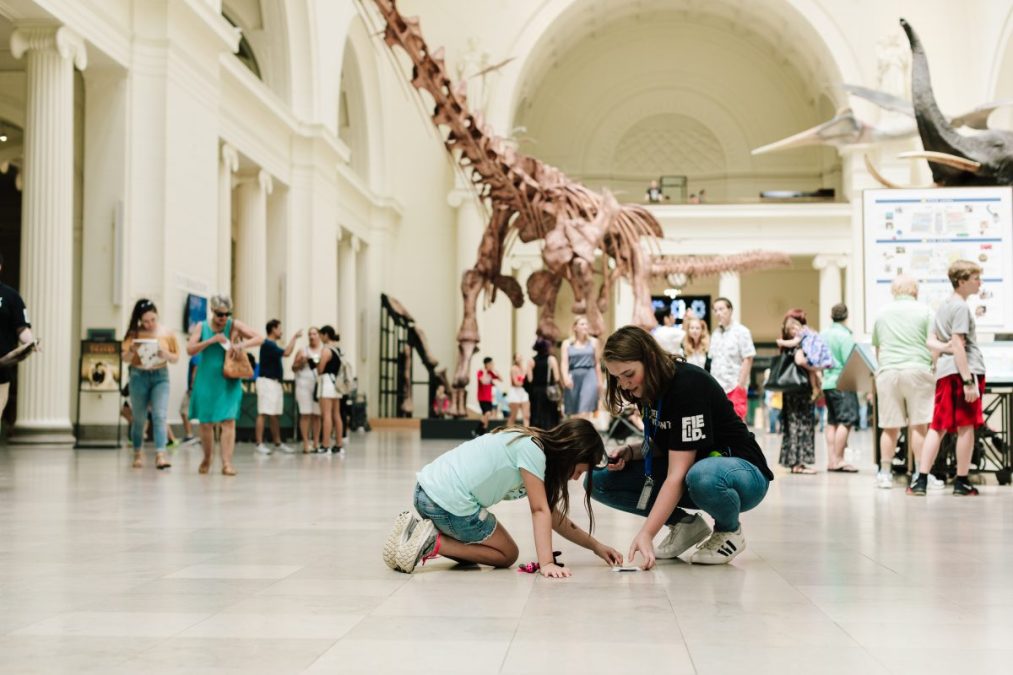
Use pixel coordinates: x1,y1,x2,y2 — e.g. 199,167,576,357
588,457,770,532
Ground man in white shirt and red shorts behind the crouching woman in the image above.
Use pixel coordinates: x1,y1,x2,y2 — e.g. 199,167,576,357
709,298,757,420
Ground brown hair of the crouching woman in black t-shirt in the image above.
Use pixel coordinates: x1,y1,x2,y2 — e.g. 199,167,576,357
602,325,677,415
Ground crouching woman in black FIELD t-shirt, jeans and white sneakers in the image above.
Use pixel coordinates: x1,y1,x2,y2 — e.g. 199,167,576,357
592,325,774,570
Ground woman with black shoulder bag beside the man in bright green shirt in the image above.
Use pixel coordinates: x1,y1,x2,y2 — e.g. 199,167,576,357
778,309,834,474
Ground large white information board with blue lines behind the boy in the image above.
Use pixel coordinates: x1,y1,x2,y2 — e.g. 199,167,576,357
863,188,1013,333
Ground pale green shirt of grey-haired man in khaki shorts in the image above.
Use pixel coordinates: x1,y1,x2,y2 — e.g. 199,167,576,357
872,295,932,372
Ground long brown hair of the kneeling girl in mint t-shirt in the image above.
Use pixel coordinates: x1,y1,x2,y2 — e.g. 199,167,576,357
492,418,605,531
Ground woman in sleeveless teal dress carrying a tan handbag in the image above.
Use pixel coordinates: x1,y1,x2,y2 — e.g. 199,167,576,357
186,295,263,475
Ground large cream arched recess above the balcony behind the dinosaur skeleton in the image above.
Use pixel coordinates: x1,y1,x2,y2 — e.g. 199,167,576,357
514,0,844,201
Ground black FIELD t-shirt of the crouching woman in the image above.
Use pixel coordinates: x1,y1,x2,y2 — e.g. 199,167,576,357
645,362,774,480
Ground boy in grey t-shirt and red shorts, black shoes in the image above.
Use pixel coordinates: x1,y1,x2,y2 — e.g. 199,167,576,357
908,260,985,497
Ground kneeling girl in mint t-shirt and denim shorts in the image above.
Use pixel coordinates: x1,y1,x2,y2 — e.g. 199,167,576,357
383,420,622,577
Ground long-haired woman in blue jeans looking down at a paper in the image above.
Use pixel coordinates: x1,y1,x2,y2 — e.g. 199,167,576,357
123,298,179,469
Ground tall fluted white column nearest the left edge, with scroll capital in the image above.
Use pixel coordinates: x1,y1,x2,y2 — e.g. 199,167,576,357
10,25,86,445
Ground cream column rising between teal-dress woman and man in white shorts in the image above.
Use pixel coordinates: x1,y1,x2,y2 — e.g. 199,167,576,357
233,170,274,331
